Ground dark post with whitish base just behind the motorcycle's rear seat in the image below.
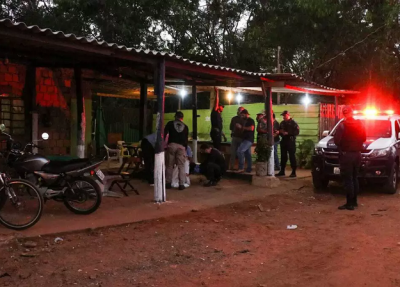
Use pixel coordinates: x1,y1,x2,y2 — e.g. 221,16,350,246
74,67,86,158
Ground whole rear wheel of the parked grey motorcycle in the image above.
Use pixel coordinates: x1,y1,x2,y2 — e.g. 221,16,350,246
64,177,102,215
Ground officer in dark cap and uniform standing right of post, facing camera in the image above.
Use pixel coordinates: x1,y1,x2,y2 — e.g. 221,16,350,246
277,111,300,177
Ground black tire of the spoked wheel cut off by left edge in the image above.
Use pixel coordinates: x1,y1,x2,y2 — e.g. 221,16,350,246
0,179,44,230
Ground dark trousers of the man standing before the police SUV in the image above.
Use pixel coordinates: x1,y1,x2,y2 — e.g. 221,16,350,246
339,152,361,205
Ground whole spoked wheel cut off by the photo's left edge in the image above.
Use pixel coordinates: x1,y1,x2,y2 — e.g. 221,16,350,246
0,179,44,230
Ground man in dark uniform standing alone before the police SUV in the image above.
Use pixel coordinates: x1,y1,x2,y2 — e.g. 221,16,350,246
334,106,366,210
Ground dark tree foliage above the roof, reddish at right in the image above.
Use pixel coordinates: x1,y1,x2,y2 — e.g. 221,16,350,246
0,0,400,94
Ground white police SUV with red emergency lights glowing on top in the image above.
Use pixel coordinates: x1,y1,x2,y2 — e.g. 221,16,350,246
312,110,400,194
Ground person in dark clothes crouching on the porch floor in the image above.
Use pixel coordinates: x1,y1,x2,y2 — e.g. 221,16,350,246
200,144,226,187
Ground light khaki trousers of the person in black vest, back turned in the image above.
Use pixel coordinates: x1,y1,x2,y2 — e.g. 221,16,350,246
165,143,186,185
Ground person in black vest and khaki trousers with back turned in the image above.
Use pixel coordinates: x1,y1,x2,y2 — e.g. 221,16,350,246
164,111,189,190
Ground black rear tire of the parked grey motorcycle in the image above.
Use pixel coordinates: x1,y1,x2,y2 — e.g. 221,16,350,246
64,177,102,215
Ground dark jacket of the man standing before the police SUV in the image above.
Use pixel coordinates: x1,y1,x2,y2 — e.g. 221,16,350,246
334,118,367,152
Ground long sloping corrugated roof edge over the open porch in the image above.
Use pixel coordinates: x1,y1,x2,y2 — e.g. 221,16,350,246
0,19,358,94
